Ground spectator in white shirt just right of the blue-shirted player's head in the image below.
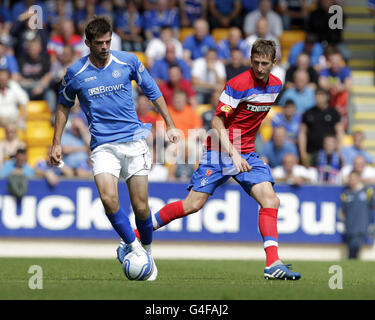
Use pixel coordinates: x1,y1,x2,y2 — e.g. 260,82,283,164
145,27,183,68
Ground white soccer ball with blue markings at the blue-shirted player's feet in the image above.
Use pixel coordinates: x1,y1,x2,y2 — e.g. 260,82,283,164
122,250,154,281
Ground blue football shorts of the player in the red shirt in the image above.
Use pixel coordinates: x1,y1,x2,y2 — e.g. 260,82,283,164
188,150,275,195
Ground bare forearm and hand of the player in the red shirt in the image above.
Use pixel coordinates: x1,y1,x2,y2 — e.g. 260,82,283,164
211,116,251,172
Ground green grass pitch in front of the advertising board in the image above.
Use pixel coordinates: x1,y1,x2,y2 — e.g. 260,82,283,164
0,258,375,300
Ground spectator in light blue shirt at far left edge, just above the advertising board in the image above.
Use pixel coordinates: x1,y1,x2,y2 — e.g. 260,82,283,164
0,148,34,179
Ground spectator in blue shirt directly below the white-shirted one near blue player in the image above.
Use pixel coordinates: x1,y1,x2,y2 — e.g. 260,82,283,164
150,42,191,83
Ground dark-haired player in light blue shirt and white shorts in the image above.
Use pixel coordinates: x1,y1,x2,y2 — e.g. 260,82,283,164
49,17,179,280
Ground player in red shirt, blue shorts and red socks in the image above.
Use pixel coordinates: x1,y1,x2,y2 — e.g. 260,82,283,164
118,39,301,280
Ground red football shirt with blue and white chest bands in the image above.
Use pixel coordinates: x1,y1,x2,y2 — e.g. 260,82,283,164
207,69,282,153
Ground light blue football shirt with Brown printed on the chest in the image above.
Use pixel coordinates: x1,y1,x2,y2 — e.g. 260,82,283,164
59,50,161,150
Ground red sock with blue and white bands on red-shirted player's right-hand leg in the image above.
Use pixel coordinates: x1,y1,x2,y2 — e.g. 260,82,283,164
259,208,279,267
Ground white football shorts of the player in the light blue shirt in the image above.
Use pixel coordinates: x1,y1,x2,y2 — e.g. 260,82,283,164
90,140,151,181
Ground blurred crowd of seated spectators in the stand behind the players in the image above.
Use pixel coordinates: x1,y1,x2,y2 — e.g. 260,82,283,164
0,0,375,185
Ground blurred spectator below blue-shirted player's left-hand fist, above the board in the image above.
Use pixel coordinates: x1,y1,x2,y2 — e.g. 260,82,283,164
34,146,74,187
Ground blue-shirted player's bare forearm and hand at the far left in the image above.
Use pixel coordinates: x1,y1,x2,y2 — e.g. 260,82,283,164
49,104,70,166
